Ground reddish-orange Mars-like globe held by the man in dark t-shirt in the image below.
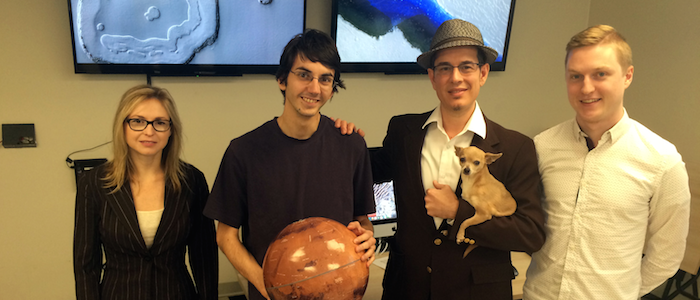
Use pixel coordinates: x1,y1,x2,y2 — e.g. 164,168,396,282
263,217,369,300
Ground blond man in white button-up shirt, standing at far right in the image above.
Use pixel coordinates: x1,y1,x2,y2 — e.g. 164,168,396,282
524,25,690,300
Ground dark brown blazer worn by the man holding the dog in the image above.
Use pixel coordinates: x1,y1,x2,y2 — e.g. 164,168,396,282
371,112,545,300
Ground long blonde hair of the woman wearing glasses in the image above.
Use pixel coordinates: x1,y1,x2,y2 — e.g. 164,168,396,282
103,84,184,193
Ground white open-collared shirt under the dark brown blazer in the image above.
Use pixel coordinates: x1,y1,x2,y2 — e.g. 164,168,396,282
420,103,486,228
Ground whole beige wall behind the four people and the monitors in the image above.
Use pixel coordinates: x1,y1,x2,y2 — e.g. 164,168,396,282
0,0,700,299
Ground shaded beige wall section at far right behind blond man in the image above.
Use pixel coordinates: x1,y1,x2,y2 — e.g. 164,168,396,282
589,0,700,166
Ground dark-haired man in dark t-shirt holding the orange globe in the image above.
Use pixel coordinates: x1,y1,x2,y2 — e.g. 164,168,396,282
204,30,375,299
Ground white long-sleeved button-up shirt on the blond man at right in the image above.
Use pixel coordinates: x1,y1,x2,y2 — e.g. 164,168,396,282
523,112,690,300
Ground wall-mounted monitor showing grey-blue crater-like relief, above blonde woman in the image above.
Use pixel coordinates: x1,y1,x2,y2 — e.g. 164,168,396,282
68,0,305,75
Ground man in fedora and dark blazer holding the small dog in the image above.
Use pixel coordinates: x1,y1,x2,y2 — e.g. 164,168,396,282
371,19,545,300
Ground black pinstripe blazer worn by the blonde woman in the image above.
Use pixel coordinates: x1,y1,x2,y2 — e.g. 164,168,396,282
73,164,219,300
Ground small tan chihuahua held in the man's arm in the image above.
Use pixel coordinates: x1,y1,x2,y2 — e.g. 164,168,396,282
455,146,518,257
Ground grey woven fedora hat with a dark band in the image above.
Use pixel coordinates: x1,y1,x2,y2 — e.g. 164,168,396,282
418,19,498,69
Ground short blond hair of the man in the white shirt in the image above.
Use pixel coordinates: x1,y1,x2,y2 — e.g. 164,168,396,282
564,25,632,69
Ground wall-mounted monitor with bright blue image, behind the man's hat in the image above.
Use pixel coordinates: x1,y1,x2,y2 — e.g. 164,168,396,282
331,0,515,73
